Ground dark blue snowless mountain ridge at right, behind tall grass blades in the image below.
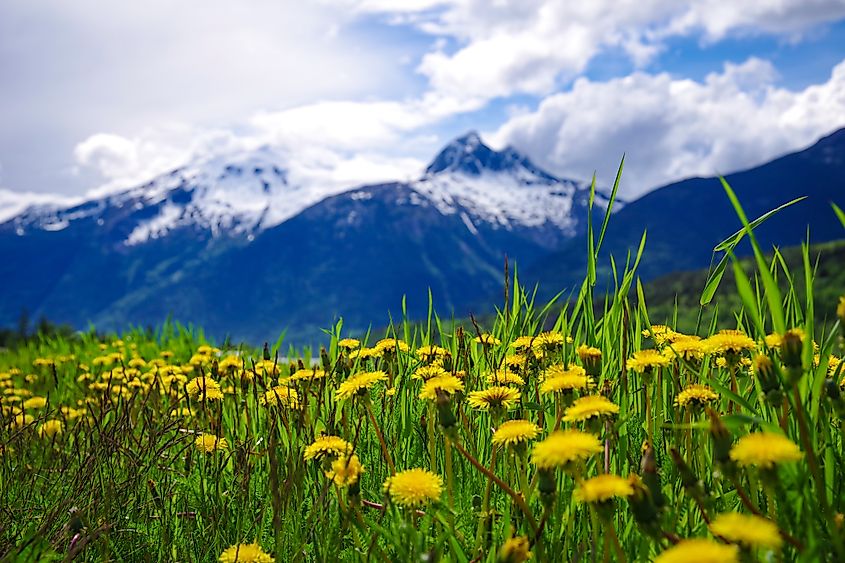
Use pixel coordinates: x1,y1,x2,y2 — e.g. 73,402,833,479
523,128,845,293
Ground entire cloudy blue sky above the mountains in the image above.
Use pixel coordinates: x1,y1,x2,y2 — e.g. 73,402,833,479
0,0,845,205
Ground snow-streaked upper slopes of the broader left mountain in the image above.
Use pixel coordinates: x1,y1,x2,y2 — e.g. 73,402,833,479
8,147,362,246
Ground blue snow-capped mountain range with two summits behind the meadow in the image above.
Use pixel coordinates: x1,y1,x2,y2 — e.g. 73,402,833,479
0,133,603,341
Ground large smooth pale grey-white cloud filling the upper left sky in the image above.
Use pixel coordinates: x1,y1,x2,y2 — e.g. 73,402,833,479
0,0,418,193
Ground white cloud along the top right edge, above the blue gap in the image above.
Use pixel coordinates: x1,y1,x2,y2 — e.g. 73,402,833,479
338,0,845,103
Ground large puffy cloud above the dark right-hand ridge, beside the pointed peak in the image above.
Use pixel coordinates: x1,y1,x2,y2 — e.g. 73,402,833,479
493,58,845,197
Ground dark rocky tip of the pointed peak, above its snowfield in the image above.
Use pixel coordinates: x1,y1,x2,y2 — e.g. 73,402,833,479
425,131,557,181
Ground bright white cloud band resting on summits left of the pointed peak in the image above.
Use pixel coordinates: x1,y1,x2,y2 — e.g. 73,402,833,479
74,101,438,197
